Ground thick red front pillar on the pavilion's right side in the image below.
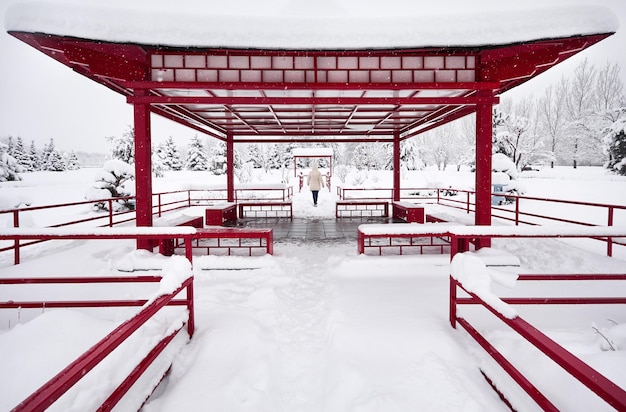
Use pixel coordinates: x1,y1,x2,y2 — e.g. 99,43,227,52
474,91,493,248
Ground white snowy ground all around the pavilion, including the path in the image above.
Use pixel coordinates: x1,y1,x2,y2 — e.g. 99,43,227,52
0,168,626,412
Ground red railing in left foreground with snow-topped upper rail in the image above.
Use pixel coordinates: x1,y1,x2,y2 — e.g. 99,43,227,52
0,228,195,412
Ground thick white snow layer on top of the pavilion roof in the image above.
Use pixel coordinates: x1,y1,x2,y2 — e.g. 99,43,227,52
5,0,619,50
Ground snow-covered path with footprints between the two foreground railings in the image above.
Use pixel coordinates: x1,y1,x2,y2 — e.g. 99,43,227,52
144,244,506,412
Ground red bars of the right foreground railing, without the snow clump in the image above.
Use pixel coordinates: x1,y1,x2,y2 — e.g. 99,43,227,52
450,227,626,411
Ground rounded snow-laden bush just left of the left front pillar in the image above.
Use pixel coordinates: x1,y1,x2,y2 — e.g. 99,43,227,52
85,159,135,212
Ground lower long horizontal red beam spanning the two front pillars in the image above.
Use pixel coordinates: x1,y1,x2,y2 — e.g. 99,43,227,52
126,96,499,106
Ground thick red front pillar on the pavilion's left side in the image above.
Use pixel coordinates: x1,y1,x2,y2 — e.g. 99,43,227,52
133,90,154,250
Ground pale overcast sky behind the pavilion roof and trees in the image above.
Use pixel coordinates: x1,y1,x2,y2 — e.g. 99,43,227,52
0,0,626,152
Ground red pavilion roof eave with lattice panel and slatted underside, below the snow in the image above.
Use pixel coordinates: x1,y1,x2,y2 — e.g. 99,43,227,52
11,32,613,143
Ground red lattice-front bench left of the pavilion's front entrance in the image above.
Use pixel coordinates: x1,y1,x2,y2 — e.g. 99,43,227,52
192,227,274,256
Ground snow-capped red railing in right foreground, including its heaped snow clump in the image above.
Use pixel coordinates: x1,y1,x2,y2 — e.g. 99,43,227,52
450,226,626,411
